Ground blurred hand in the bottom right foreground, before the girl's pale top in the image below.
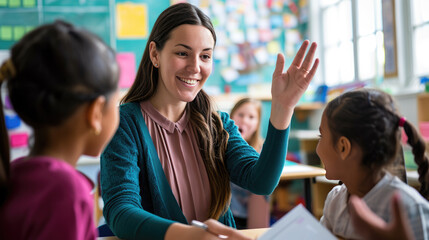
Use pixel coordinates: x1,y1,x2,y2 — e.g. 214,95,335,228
349,193,414,240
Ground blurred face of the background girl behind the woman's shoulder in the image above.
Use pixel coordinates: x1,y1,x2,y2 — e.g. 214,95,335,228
231,102,259,141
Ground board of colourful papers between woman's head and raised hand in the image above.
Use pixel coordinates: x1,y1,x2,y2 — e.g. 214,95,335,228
180,0,309,93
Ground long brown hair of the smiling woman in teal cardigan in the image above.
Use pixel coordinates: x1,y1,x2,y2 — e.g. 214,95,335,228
121,3,231,219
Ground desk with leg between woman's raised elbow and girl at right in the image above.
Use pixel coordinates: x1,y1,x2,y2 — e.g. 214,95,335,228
280,161,326,213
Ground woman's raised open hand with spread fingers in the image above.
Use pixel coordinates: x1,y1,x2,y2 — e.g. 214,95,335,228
270,40,319,129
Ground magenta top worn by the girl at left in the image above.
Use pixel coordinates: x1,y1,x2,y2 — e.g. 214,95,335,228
0,157,97,240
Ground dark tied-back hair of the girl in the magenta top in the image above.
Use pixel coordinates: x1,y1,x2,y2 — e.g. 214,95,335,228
0,21,119,202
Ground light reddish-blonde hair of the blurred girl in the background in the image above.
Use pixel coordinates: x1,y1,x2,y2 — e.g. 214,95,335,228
230,98,263,152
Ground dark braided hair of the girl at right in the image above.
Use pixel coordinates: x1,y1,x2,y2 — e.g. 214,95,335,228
325,88,429,198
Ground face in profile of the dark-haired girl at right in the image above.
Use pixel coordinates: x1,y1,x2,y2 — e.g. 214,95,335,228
316,113,342,180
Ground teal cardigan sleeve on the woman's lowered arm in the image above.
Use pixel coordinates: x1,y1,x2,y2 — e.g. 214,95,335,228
101,104,174,239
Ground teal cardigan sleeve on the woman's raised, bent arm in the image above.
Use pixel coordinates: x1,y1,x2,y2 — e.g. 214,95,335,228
221,112,289,195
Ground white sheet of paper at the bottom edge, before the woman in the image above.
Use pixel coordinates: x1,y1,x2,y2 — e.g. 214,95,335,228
258,204,337,240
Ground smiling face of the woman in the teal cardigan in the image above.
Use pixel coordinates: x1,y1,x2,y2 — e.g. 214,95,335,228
152,24,215,102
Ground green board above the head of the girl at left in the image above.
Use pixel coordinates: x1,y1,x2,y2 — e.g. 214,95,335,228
0,0,113,50
